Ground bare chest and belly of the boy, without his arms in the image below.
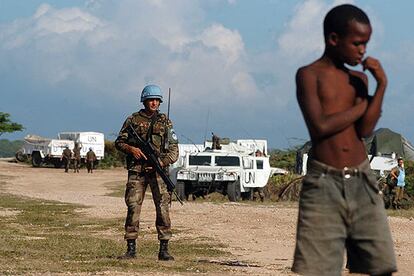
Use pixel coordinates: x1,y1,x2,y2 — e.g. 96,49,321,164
301,60,367,168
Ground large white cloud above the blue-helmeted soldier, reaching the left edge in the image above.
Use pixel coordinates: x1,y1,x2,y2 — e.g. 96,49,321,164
0,0,257,109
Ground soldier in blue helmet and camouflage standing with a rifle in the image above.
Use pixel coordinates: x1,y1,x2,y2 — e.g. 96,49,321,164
115,85,178,261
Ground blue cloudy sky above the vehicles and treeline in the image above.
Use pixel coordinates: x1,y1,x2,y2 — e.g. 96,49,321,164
0,0,414,148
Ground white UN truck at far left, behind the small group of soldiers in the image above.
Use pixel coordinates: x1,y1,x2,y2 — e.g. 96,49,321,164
16,132,105,168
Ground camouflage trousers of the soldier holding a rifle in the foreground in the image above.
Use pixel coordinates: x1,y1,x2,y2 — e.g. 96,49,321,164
124,171,172,240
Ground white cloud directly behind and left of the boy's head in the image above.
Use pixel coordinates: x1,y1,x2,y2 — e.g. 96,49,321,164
270,0,374,107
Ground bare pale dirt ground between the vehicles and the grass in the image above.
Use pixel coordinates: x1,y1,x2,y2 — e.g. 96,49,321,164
0,160,414,275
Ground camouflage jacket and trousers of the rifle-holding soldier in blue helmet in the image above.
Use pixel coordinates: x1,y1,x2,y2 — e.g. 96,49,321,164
115,109,178,241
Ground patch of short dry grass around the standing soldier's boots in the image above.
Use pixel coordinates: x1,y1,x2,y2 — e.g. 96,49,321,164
0,193,229,275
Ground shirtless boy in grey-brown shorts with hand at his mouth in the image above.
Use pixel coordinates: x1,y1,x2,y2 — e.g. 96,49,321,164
292,5,396,275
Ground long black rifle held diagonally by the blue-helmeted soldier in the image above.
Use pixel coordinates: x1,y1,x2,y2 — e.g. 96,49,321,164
125,125,183,205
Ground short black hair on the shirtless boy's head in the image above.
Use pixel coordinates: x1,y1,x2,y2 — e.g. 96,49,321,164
323,4,371,40
